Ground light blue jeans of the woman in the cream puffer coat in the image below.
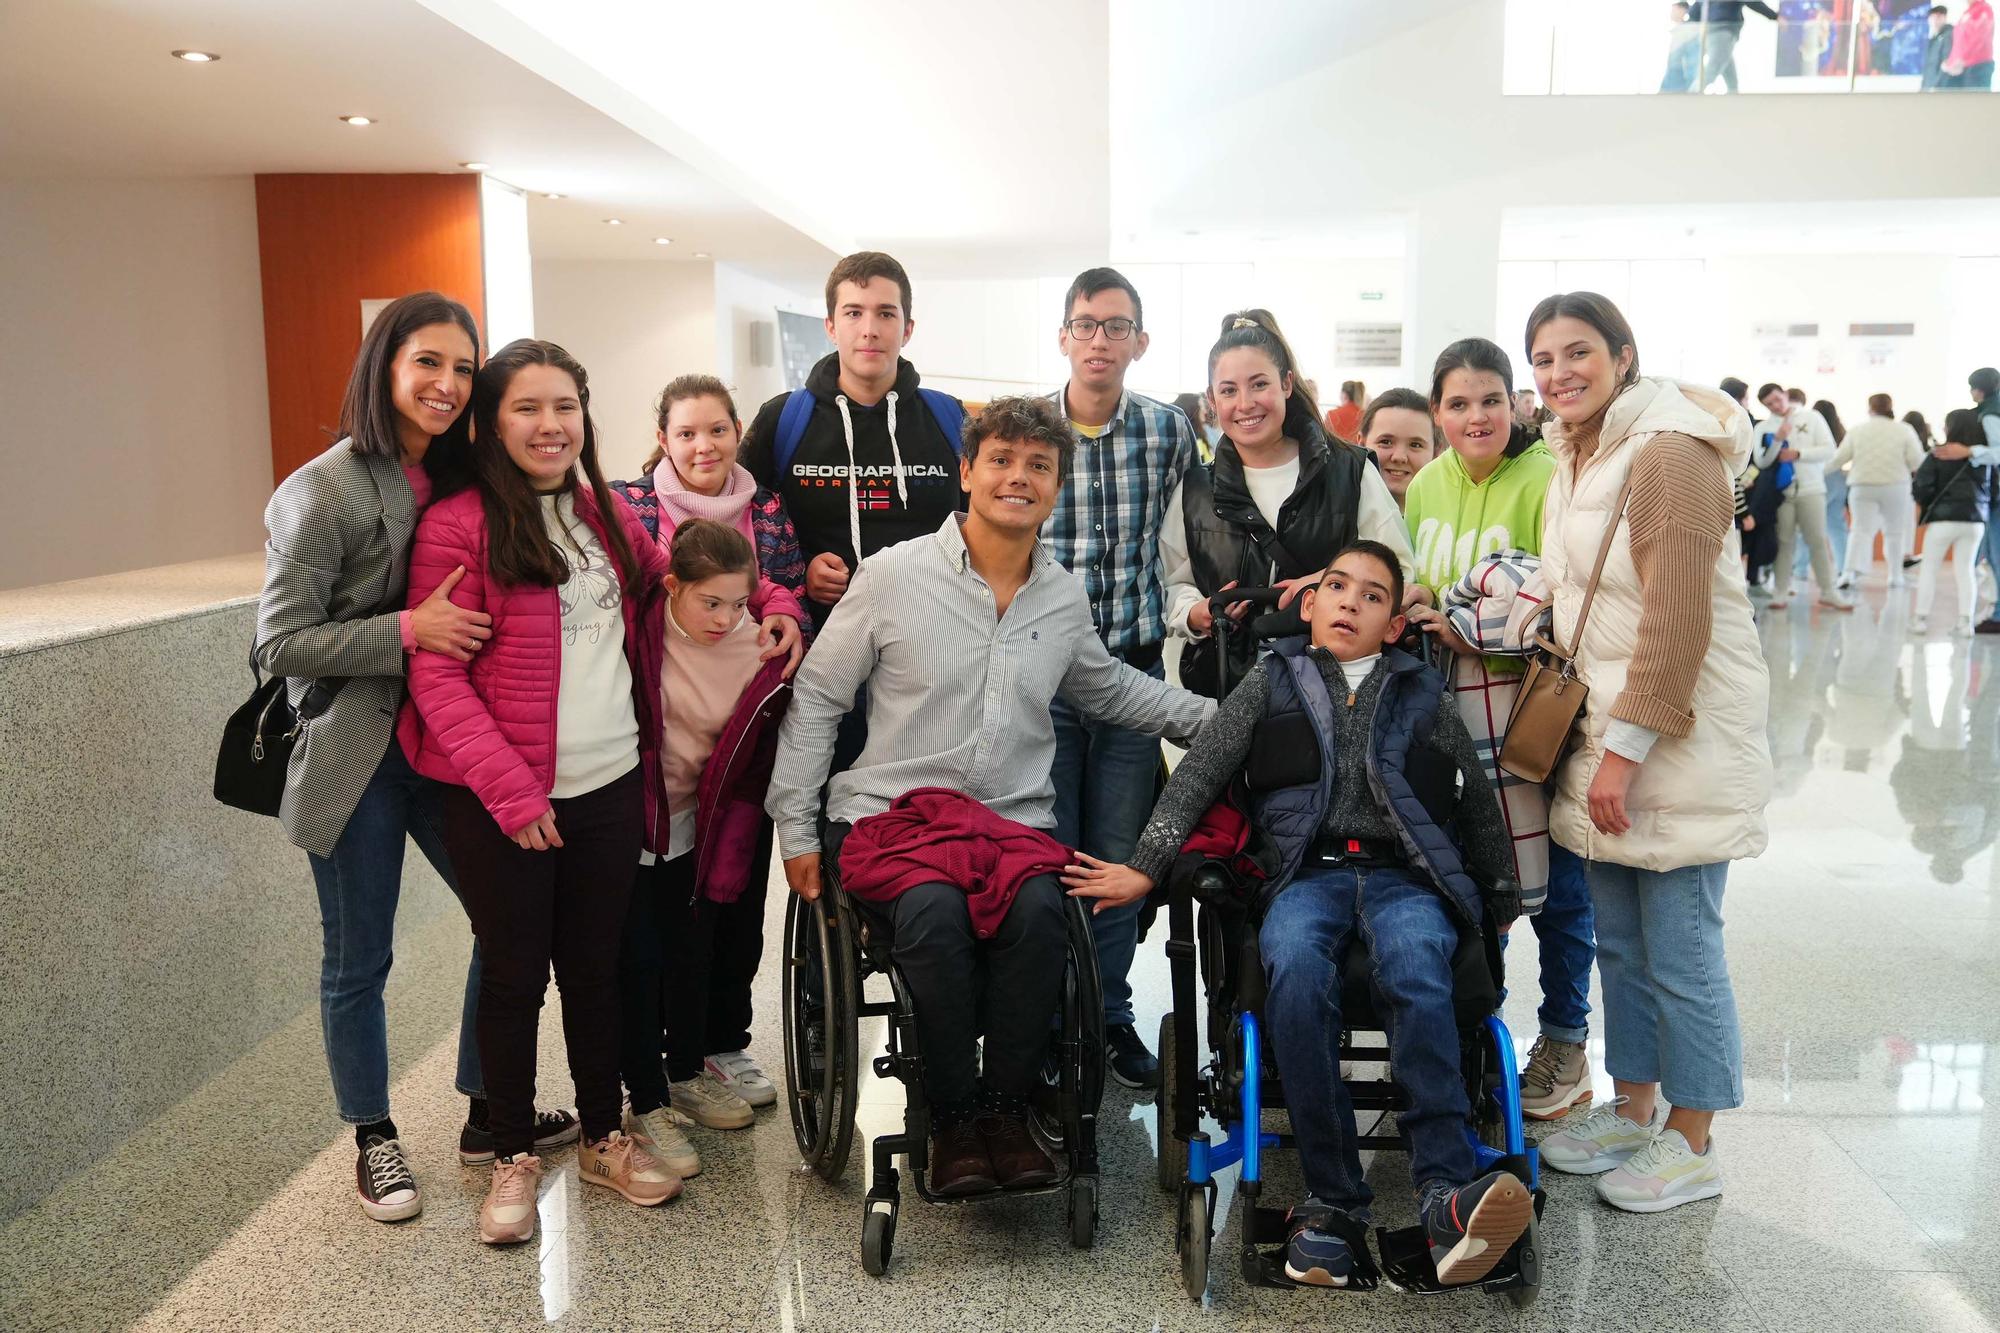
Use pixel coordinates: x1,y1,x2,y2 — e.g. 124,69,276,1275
1584,861,1744,1111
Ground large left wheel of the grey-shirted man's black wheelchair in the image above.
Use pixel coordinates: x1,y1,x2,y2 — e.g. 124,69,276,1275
784,891,860,1181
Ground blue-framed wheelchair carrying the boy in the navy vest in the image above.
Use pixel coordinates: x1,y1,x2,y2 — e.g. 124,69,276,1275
1158,588,1544,1307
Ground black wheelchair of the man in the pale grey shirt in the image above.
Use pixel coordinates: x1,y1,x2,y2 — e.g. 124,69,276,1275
784,844,1104,1277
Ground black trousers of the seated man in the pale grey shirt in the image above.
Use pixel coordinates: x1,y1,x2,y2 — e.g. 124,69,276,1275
824,825,1068,1113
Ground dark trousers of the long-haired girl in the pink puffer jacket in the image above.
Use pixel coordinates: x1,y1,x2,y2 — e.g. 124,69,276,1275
444,767,646,1157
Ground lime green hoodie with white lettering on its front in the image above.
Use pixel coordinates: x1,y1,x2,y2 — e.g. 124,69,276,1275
1402,440,1556,598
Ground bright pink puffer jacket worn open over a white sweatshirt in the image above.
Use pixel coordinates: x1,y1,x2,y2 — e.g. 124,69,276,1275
396,486,668,851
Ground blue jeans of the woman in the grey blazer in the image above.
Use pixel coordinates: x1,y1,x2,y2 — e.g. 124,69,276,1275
306,737,486,1125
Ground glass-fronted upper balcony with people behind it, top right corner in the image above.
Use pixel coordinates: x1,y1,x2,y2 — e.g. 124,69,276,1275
1502,0,1994,96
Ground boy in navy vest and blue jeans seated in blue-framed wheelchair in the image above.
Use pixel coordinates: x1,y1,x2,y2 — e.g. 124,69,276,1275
1064,540,1534,1287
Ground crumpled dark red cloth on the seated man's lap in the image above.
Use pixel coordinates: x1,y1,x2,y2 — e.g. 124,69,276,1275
840,787,1072,939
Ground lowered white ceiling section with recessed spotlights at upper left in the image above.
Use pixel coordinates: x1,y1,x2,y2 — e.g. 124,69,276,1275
0,0,828,272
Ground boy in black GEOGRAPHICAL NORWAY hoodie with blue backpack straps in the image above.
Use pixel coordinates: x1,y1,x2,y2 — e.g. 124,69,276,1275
740,250,964,624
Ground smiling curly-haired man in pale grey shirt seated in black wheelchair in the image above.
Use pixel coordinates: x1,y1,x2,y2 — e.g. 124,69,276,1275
766,398,1214,1195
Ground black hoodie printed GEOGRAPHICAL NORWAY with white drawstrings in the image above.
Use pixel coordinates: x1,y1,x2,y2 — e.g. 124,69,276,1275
740,354,960,570
